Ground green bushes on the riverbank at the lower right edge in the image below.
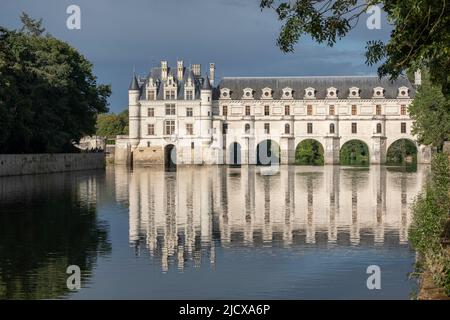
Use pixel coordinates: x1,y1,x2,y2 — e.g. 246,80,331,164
409,154,450,296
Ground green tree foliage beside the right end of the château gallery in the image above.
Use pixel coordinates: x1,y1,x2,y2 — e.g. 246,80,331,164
409,71,450,150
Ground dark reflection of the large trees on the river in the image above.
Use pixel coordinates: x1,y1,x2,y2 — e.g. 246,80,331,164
0,172,111,299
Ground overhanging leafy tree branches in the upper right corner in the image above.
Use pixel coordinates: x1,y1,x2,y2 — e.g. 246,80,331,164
260,0,450,94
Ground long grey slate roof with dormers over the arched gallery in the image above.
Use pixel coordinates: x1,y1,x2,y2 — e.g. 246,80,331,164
213,76,415,100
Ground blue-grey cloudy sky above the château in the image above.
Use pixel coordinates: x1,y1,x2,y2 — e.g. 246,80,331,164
0,0,390,112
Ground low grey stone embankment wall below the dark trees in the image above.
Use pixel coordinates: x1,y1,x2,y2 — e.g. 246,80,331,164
0,153,105,176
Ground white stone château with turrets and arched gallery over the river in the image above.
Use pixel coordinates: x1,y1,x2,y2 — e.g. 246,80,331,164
116,61,431,165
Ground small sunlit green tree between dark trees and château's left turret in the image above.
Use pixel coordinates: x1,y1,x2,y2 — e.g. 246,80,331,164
95,110,128,139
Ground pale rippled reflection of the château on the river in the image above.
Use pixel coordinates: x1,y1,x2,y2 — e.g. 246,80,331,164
126,166,428,271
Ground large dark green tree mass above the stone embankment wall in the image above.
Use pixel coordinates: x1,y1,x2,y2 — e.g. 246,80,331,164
0,15,111,153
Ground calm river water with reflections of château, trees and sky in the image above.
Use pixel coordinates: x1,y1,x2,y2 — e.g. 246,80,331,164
0,166,428,299
